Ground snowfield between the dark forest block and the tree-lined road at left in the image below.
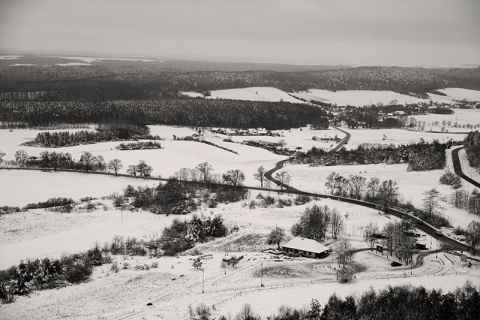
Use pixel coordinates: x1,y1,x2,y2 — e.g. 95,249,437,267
0,126,285,186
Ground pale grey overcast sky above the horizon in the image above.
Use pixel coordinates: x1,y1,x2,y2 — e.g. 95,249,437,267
0,0,480,65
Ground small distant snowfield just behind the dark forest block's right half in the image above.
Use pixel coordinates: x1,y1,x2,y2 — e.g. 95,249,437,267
207,87,304,103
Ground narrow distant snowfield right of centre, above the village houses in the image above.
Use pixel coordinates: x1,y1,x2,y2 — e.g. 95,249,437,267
293,89,429,107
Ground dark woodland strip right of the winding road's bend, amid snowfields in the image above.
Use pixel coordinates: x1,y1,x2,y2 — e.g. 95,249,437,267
292,140,452,171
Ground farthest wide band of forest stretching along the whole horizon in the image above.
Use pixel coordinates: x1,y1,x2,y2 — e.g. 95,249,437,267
0,62,480,101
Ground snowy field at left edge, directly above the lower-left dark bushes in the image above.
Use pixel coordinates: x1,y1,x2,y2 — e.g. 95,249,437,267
0,206,178,269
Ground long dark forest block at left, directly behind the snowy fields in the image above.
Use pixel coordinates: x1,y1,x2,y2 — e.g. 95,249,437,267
0,99,326,130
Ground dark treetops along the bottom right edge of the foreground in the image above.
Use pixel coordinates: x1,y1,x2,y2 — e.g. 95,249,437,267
204,282,480,320
